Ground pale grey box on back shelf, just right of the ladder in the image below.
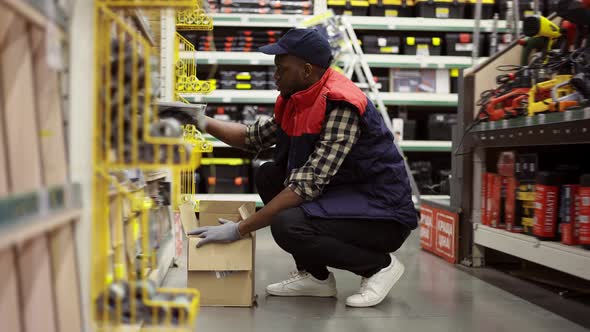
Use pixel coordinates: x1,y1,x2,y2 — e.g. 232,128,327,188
390,68,449,93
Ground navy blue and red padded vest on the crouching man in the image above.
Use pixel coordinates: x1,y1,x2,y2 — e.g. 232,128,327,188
275,69,418,229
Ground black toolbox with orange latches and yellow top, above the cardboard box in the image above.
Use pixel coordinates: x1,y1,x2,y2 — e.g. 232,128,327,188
199,158,250,194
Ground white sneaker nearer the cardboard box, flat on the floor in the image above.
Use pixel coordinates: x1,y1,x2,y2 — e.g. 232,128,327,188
266,271,336,297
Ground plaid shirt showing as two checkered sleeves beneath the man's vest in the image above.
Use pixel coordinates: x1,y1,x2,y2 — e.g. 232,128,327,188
246,105,361,201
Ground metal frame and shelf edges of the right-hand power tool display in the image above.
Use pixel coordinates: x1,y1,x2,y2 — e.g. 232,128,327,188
460,34,590,280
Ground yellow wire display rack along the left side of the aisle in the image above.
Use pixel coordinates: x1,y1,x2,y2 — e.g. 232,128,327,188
90,0,212,331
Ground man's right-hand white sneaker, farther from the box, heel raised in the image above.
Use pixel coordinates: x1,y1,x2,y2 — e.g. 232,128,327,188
346,254,405,307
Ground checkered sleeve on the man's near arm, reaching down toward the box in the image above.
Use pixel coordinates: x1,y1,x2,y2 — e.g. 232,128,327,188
285,105,361,201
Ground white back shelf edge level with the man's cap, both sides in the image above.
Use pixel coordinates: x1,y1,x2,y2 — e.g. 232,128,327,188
192,52,485,69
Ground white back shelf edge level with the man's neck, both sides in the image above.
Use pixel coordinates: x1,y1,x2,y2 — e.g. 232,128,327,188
180,90,458,107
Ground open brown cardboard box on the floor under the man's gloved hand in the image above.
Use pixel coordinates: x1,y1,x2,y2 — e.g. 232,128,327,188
180,200,256,307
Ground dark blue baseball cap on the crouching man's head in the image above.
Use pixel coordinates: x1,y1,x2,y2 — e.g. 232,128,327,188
258,29,332,68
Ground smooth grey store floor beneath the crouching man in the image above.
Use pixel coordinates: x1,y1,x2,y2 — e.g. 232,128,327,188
164,229,586,332
